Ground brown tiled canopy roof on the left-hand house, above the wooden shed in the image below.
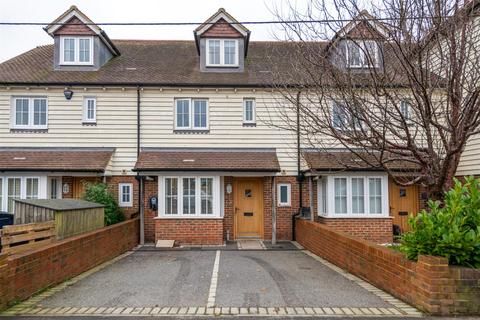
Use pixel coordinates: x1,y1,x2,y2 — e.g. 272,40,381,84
0,148,115,172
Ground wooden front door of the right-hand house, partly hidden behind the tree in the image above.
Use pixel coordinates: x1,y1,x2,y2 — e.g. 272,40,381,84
388,179,419,232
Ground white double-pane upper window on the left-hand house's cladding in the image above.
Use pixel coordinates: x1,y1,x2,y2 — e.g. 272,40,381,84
12,97,48,129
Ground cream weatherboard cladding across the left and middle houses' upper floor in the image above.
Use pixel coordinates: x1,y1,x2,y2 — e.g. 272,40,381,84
0,87,296,175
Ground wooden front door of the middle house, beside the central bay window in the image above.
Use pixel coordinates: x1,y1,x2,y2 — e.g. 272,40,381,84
234,178,263,238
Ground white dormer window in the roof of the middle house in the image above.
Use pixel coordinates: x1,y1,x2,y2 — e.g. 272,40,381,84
207,39,238,67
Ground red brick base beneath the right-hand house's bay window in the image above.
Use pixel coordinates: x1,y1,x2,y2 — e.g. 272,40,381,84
318,217,393,243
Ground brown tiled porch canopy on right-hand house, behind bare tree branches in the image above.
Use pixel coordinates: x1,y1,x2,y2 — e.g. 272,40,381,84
302,149,420,173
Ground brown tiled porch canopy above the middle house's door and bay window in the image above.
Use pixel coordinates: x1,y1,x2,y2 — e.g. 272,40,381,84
133,148,280,172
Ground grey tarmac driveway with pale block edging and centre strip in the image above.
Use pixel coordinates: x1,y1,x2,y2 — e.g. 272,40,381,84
0,245,421,318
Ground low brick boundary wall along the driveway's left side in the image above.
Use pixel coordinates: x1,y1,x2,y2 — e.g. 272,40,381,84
0,219,139,310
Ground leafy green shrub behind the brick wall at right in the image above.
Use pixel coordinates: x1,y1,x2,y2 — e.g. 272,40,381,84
400,177,480,268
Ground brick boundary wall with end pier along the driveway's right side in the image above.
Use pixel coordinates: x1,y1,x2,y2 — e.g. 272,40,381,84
296,220,480,315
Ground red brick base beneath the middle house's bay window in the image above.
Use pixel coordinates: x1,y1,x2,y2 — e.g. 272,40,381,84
155,219,223,245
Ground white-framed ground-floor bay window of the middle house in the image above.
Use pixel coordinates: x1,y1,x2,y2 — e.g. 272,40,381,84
159,176,220,218
